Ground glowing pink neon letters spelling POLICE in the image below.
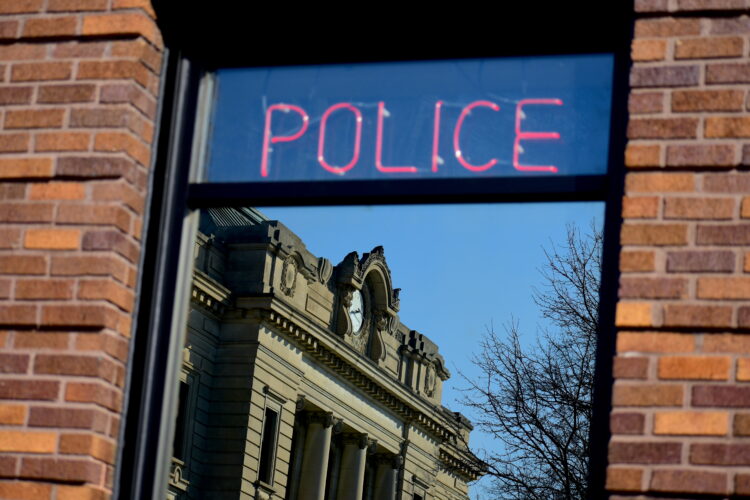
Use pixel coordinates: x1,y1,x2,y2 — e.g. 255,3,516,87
260,98,563,177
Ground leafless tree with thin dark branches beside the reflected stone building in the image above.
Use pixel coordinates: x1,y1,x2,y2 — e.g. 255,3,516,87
463,224,602,500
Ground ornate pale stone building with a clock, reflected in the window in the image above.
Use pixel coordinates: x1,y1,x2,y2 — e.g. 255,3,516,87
169,205,479,500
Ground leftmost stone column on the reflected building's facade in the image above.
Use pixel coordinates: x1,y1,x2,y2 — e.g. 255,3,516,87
298,413,333,500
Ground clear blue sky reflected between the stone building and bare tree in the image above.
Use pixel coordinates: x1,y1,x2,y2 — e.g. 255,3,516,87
261,202,604,497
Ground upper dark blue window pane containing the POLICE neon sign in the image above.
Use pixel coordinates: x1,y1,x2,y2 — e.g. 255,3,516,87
206,55,612,182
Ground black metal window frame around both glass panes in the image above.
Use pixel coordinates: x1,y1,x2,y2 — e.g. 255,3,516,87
114,5,633,499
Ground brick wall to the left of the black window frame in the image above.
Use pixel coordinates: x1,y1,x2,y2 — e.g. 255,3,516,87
0,0,162,500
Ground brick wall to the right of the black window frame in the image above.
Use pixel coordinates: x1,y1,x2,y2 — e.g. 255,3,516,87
607,0,750,498
